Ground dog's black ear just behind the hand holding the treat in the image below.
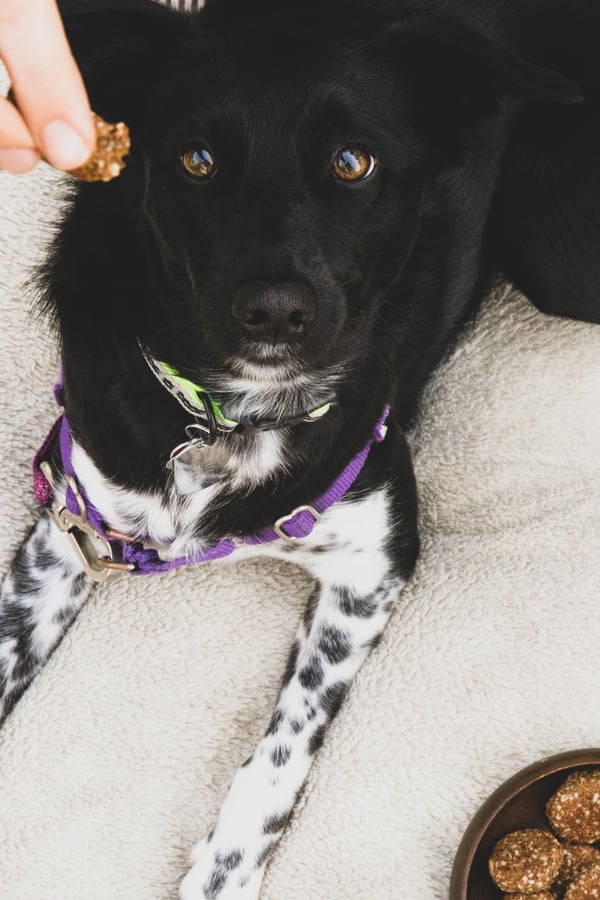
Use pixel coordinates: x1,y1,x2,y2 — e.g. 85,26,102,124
59,0,189,127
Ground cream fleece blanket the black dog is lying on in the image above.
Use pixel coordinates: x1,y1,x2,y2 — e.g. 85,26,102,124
0,155,600,900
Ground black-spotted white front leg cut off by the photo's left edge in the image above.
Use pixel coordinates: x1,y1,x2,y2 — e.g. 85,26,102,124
0,514,92,722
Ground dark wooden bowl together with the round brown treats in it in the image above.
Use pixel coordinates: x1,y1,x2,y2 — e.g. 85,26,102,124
449,749,600,900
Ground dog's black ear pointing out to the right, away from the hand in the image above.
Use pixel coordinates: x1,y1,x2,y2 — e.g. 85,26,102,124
383,18,584,135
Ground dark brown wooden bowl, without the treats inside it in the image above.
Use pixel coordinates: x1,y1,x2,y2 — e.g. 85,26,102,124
449,749,600,900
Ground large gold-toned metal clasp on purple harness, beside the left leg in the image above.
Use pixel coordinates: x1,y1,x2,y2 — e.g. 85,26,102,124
40,462,135,582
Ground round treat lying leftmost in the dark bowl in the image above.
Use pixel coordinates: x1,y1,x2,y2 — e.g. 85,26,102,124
489,828,563,894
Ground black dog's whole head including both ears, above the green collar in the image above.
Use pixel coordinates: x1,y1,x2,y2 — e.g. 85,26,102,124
56,0,576,408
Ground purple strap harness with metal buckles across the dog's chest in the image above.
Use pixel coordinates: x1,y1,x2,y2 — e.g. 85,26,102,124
33,386,390,581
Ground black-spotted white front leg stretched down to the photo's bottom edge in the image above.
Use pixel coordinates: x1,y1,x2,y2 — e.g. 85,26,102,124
180,491,406,900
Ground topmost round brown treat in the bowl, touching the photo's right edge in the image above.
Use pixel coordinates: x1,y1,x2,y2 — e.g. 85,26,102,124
546,770,600,844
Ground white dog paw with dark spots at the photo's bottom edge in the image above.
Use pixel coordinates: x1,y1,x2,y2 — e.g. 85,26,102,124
179,838,263,900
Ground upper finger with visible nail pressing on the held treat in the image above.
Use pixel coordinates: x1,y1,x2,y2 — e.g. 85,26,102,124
0,0,95,169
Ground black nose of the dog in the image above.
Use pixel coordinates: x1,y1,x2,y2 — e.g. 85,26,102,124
231,281,317,344
